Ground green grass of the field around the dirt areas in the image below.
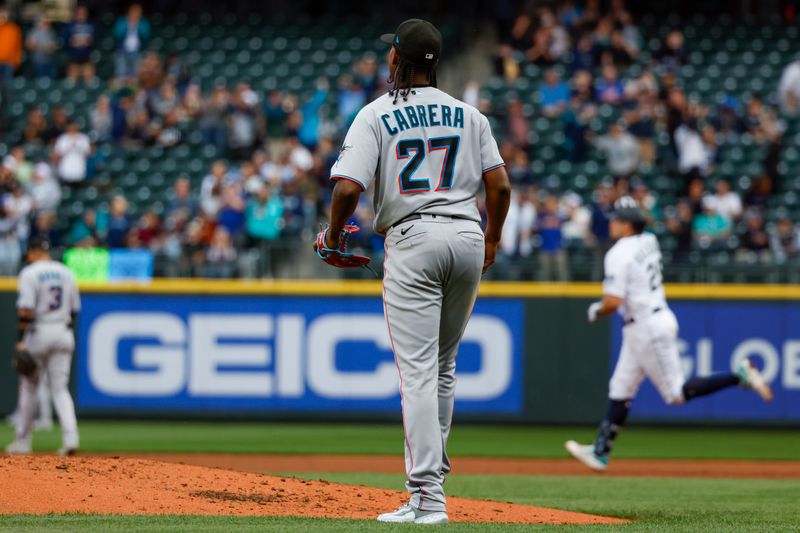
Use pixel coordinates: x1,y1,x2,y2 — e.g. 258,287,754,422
0,421,800,533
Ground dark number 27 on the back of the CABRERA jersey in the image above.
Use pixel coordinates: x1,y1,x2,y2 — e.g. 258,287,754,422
397,136,460,194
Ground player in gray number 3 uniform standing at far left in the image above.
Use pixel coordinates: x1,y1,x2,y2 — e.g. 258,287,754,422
6,239,81,455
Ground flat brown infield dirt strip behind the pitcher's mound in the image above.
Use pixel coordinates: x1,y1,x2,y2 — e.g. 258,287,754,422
126,453,800,479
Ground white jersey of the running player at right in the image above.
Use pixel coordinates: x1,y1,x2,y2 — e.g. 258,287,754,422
603,233,667,320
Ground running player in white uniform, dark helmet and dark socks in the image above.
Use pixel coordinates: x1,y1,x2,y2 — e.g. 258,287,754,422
565,197,772,470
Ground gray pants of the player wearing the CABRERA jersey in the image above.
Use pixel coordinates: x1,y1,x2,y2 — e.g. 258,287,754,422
383,215,484,511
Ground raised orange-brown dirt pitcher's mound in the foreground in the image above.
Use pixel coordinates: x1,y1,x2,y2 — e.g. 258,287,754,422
0,456,626,524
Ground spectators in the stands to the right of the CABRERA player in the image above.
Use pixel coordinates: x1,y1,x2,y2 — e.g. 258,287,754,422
484,0,800,280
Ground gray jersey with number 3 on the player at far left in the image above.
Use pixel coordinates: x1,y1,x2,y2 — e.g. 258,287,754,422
17,261,81,324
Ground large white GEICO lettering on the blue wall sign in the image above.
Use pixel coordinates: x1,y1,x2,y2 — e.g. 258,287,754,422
86,312,514,401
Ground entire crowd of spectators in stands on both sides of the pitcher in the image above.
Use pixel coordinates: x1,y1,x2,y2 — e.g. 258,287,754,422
0,0,800,280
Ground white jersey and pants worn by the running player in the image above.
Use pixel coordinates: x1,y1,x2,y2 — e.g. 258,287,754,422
603,233,685,404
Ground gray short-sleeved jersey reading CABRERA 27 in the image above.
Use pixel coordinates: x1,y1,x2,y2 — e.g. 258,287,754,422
331,87,503,233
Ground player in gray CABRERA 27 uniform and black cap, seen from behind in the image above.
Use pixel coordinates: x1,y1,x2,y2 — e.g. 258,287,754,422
318,19,510,524
